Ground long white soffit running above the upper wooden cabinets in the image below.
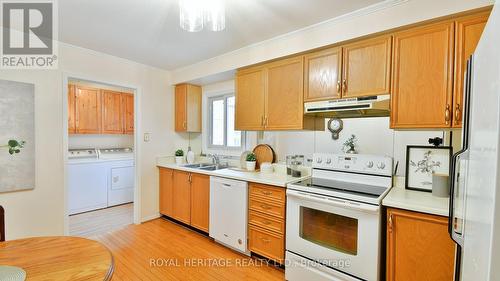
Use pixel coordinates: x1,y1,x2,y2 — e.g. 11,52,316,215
172,0,495,83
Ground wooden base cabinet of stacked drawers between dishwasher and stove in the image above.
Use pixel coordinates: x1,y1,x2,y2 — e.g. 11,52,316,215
248,183,286,263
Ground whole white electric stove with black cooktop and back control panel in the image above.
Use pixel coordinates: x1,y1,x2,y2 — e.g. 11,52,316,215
285,154,393,281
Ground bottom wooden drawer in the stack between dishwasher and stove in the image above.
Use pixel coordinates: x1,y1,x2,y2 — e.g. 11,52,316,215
249,226,285,263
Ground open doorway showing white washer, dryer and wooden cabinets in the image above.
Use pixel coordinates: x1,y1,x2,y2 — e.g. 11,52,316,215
63,76,139,238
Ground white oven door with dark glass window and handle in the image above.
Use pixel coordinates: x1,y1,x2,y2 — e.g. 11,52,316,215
286,189,380,280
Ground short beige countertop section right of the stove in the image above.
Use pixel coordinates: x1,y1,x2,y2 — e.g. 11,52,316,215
382,177,449,214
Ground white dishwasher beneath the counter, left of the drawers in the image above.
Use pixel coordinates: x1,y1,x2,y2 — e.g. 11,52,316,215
209,177,250,255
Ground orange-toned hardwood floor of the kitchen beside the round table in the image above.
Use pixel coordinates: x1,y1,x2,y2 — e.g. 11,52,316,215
94,218,284,281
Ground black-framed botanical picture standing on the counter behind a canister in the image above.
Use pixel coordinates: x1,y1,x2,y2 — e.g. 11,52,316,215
405,145,452,192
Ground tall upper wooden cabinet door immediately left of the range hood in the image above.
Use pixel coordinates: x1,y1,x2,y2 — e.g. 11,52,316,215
264,56,304,130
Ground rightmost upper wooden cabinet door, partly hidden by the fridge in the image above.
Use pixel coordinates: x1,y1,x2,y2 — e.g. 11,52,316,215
453,11,490,128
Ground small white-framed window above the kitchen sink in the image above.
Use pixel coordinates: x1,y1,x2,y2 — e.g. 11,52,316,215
208,94,244,149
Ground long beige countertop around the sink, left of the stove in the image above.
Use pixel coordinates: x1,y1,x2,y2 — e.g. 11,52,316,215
156,157,310,187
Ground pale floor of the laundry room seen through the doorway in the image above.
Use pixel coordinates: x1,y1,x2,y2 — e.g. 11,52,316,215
69,203,134,238
